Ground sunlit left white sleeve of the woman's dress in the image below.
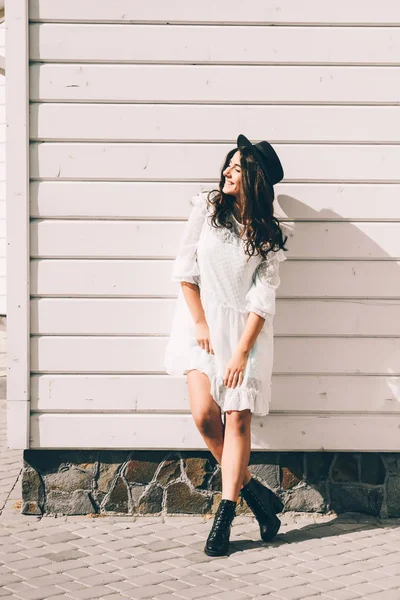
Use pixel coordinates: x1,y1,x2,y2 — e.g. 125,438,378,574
171,194,207,285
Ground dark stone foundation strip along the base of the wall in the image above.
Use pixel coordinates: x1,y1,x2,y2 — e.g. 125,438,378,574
22,450,400,518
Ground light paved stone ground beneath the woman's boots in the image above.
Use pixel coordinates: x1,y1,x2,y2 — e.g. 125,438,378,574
0,331,400,600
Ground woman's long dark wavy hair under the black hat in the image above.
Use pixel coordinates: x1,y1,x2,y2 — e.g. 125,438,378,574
207,147,287,258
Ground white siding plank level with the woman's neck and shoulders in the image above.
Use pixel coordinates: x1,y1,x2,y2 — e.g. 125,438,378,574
31,183,400,220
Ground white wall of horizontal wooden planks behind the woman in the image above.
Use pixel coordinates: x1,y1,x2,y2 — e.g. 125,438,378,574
9,0,400,451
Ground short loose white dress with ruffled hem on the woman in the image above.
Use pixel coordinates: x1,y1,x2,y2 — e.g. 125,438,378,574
164,192,286,416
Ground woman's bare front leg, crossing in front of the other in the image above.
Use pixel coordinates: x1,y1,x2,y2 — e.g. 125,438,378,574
221,409,251,502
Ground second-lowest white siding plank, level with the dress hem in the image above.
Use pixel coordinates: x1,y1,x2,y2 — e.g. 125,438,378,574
31,375,400,414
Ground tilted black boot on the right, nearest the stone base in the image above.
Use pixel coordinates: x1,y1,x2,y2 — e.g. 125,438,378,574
240,477,284,542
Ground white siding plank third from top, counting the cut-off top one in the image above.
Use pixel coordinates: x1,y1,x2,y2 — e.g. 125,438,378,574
30,63,400,104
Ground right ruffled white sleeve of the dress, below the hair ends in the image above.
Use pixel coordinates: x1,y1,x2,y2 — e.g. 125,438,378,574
245,250,286,319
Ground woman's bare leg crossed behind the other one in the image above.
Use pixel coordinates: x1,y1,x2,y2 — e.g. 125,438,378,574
187,369,251,487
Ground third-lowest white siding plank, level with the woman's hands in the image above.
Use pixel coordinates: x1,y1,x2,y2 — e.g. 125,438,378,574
31,336,400,375
